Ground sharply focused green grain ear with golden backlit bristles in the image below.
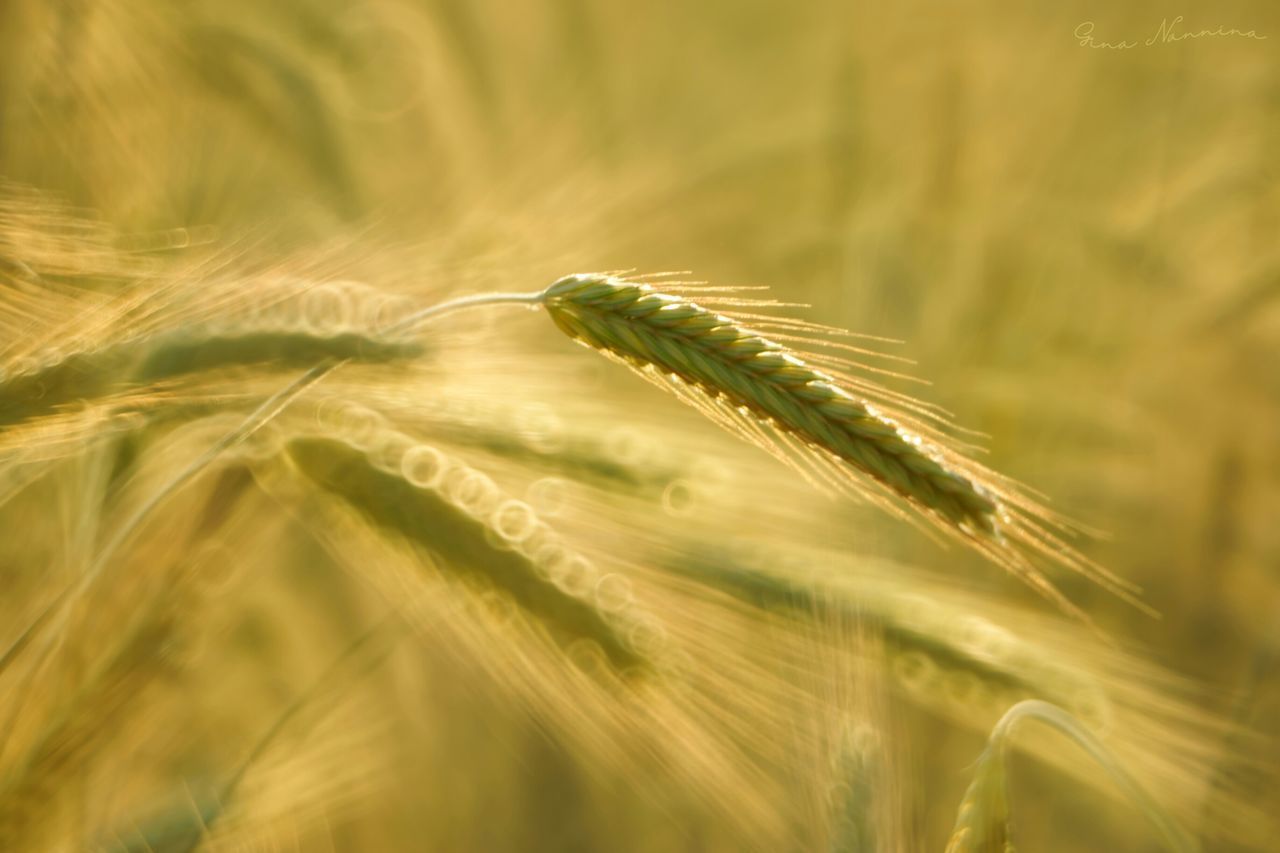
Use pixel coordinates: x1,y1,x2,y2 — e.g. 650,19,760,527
541,274,1134,620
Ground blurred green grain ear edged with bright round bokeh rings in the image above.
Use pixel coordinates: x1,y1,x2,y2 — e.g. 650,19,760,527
285,437,649,674
